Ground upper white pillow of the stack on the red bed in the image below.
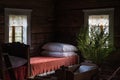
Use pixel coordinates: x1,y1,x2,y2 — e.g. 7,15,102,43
42,43,77,52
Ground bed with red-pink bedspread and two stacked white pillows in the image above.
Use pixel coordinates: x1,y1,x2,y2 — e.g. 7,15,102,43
30,42,79,76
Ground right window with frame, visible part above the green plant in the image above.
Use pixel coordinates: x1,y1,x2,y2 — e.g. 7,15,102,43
84,8,114,44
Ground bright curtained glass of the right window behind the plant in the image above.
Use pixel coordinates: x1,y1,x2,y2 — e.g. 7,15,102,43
88,15,109,47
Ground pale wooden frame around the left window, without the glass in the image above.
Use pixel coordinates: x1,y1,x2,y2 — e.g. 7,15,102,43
5,8,32,45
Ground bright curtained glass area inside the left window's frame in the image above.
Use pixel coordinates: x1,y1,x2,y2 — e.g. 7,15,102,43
9,15,27,43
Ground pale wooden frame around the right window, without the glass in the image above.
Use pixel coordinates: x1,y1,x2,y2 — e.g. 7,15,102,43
83,8,114,45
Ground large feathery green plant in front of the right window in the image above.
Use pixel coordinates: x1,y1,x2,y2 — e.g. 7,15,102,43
77,26,114,65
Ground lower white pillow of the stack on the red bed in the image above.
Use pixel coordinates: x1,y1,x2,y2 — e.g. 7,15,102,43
41,51,77,57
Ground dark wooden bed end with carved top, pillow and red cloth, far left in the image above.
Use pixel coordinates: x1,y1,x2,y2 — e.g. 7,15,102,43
1,42,29,80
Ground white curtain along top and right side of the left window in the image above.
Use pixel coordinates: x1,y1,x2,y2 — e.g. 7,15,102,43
9,15,27,44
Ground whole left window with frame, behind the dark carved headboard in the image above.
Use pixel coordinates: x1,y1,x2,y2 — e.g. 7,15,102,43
5,8,31,45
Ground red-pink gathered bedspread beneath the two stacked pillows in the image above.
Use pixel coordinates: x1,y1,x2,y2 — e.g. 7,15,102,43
30,56,78,76
